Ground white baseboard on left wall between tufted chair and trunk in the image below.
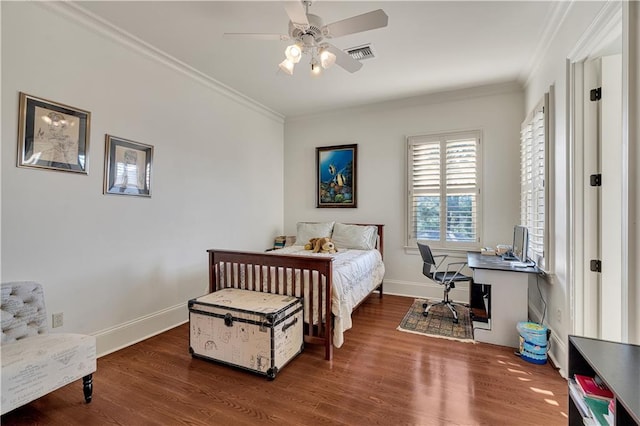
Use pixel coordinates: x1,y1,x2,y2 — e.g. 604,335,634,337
94,303,189,357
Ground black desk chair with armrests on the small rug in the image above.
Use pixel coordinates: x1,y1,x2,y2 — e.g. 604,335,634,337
418,242,473,324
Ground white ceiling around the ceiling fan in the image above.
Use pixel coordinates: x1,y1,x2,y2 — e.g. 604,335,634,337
77,0,559,117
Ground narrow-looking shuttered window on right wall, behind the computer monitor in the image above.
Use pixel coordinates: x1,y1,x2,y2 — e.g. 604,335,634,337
520,94,549,269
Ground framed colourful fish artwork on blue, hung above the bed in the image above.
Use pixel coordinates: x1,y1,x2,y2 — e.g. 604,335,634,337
316,144,358,208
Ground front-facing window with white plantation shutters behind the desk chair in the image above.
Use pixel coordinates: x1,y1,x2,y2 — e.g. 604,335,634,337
407,131,481,248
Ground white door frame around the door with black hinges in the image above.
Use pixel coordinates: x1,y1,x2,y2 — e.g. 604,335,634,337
566,1,640,344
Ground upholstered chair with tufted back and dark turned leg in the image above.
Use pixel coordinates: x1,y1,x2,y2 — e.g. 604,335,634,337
0,281,96,414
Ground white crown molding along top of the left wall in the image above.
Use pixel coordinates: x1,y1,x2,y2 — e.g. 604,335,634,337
34,1,284,123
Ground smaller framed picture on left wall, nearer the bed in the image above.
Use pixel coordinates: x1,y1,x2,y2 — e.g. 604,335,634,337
104,135,153,197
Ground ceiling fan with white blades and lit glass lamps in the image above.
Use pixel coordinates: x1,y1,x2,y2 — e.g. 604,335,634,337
224,0,389,75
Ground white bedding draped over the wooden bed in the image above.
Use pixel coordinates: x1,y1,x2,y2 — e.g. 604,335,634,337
269,245,385,348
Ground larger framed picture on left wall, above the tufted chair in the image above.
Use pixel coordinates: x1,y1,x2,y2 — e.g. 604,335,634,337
18,92,91,175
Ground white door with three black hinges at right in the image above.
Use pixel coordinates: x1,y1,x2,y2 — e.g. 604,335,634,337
583,55,623,341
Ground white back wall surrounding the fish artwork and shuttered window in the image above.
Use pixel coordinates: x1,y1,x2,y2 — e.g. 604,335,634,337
284,84,524,300
